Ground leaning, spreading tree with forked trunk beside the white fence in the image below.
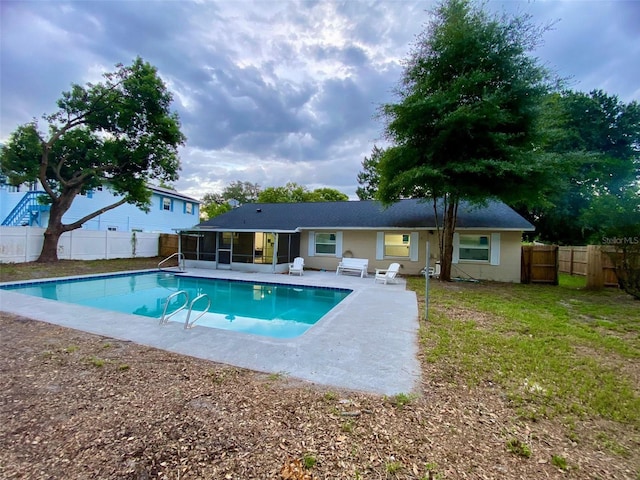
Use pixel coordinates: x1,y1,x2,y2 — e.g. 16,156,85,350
0,58,185,262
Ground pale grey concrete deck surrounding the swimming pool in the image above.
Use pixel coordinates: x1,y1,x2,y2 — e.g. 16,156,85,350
0,268,421,395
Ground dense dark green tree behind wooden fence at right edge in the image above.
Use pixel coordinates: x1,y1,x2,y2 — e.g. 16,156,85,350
520,90,640,245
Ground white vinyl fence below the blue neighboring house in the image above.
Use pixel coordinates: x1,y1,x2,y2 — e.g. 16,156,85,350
0,227,160,263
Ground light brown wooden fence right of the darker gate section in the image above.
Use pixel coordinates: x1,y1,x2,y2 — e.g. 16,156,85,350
558,245,618,288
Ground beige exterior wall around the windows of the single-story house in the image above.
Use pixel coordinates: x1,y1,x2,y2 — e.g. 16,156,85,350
300,229,522,283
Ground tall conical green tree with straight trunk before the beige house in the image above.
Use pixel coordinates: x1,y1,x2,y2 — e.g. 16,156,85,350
378,0,549,280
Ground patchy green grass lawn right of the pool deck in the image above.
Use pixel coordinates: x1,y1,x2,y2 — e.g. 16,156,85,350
408,275,640,456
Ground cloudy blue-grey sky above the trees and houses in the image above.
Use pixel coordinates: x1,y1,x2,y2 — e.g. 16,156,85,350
0,0,640,199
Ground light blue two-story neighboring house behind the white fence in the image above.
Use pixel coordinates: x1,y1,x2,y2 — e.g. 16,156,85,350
0,184,200,233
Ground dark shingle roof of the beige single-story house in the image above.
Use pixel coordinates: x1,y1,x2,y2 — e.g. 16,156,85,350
196,199,534,232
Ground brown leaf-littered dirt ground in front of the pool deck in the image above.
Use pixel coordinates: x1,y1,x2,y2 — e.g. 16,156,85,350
0,260,640,480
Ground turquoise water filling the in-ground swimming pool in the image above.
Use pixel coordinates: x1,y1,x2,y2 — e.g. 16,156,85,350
0,272,351,338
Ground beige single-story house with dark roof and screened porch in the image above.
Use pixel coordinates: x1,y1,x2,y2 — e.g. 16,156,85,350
178,199,534,282
